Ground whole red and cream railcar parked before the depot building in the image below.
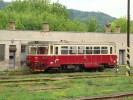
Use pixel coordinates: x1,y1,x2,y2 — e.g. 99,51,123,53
27,41,117,71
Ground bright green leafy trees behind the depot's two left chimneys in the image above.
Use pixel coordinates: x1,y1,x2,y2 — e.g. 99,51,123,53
0,0,87,31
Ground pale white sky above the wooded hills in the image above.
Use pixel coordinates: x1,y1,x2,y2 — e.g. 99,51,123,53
4,0,133,20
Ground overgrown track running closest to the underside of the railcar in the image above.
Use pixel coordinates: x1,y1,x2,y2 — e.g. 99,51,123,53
0,73,133,80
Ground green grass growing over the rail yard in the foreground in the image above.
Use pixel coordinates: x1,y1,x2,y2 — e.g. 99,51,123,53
0,67,133,100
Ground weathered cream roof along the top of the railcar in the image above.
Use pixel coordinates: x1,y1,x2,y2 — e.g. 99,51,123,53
28,40,115,45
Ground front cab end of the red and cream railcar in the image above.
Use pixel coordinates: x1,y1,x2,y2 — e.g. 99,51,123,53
26,41,49,71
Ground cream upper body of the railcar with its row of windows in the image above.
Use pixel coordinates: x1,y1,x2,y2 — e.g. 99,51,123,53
26,41,115,55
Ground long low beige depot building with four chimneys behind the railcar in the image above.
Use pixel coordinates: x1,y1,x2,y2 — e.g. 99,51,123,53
0,22,133,70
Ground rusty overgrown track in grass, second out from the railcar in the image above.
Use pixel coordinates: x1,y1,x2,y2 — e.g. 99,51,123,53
0,75,117,84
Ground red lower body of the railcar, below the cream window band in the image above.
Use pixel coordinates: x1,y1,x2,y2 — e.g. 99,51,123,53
27,55,117,71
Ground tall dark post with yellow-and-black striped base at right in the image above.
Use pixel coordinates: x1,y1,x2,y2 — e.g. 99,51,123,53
126,0,130,76
